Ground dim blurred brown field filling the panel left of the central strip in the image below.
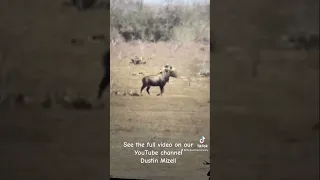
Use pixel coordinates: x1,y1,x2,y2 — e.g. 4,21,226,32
0,0,109,180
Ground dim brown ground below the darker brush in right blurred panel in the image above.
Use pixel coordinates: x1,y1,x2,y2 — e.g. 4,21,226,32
210,50,319,180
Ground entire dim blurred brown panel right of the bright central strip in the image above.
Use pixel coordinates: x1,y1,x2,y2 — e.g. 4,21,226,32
210,0,319,180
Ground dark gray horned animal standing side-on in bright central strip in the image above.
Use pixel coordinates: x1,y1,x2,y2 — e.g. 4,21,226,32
140,69,178,96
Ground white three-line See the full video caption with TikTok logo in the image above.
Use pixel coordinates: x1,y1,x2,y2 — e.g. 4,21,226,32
123,136,208,164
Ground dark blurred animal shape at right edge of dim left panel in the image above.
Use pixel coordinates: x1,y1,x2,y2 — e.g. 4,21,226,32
97,50,110,99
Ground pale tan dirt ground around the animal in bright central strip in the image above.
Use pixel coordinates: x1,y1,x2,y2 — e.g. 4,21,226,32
110,42,210,179
